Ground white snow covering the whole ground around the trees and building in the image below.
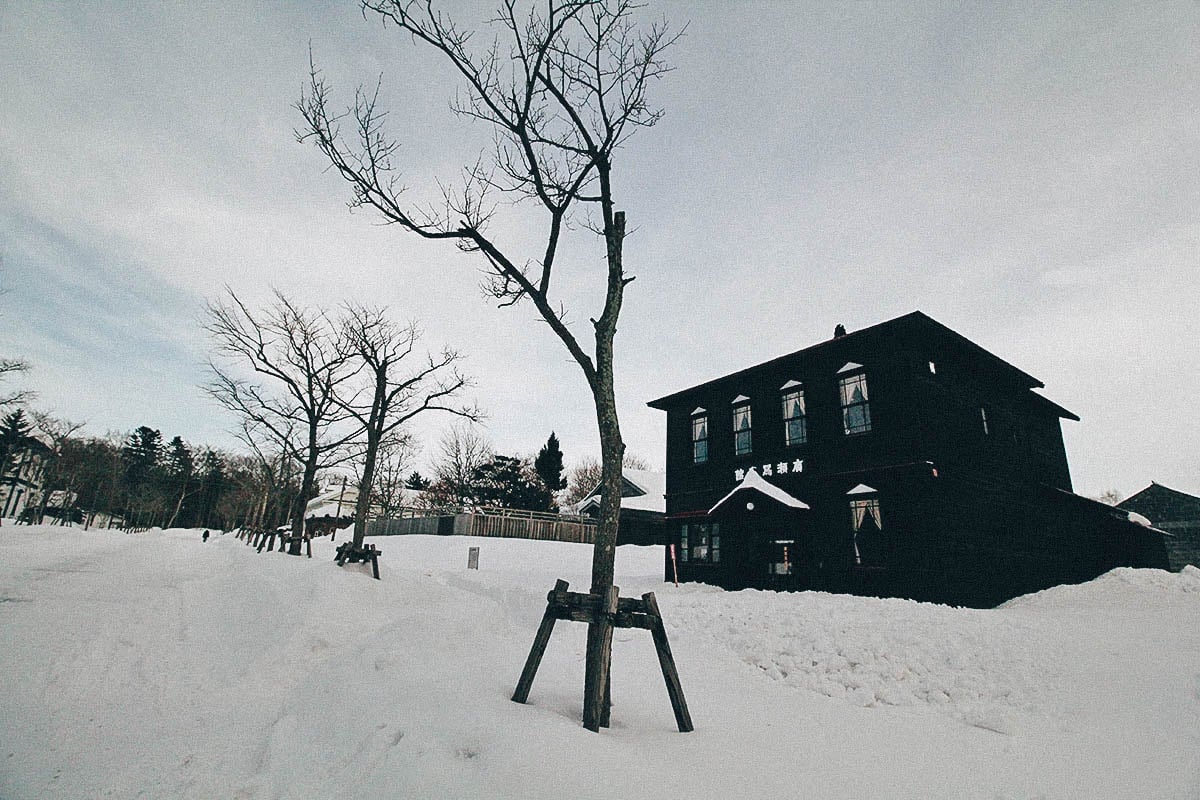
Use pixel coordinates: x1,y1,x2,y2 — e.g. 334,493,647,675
0,524,1200,800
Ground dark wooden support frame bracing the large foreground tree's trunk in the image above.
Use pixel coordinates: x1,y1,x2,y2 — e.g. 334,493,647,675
512,581,695,733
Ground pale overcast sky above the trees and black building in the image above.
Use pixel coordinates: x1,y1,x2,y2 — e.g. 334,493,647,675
0,0,1200,494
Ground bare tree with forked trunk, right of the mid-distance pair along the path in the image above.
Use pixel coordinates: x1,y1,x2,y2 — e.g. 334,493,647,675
340,305,479,551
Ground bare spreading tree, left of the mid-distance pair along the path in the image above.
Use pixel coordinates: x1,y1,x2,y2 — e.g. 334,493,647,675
205,289,355,555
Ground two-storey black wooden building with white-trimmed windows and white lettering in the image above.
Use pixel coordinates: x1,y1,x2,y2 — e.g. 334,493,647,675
649,312,1166,606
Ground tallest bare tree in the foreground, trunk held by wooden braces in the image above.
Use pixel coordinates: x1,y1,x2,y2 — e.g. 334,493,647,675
298,0,677,730
